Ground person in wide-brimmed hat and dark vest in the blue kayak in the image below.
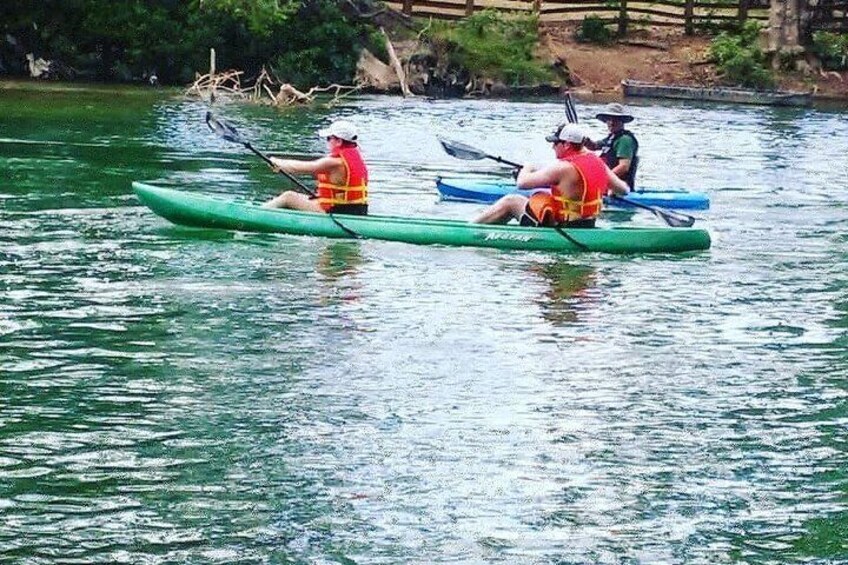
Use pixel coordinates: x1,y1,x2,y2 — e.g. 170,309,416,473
584,102,639,190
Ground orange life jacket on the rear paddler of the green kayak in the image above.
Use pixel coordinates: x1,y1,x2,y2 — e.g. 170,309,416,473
527,152,609,226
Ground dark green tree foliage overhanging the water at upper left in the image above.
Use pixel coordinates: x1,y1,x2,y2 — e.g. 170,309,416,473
0,0,372,86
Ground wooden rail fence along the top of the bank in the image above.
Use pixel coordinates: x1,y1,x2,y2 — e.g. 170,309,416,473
386,0,776,35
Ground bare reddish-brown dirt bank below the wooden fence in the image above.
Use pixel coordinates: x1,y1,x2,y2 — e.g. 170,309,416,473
540,25,848,100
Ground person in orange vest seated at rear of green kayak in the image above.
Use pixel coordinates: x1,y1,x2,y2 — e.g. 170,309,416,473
472,124,628,228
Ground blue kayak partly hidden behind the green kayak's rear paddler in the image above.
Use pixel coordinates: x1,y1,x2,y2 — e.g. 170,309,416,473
436,177,710,210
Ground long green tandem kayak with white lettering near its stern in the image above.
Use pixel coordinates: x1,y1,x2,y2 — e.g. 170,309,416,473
133,182,710,253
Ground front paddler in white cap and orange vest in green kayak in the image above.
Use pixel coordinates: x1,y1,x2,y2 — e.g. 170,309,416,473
264,120,368,216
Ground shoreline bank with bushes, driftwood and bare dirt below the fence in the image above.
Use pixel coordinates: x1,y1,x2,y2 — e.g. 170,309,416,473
0,0,848,106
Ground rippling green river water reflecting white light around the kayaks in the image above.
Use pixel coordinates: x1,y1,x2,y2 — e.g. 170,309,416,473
0,82,848,564
